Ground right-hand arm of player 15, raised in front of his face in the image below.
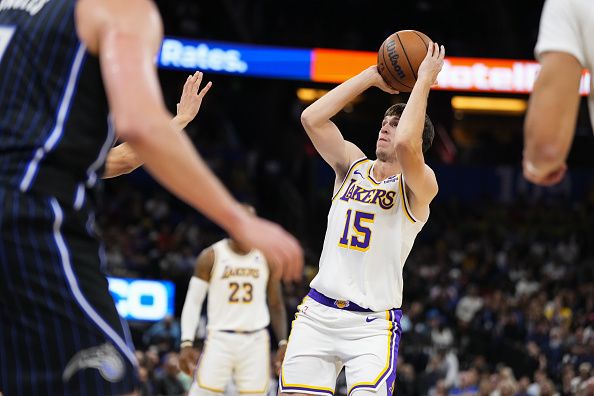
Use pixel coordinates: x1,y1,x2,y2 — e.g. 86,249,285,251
395,43,445,210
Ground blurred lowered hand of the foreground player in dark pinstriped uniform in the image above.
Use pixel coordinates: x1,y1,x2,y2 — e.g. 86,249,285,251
229,213,303,282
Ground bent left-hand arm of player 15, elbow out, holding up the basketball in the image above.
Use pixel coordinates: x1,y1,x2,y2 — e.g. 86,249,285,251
301,68,397,179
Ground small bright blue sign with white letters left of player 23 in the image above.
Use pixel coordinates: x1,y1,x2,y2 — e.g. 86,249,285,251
107,277,175,321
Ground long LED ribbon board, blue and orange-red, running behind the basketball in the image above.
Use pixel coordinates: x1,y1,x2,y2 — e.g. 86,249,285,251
157,37,591,95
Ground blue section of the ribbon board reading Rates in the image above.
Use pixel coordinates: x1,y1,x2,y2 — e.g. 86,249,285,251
157,37,312,80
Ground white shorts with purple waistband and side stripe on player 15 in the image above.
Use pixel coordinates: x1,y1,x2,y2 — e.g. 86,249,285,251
279,290,402,395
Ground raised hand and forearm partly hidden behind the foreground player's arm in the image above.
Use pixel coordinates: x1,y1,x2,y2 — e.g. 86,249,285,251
103,71,212,179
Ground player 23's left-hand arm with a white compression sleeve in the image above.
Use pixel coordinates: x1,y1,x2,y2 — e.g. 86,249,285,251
179,247,215,375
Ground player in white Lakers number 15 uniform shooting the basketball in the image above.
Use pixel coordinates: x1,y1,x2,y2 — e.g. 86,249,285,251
279,43,445,395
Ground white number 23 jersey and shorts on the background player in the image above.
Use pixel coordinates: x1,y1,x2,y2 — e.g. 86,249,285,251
189,239,270,396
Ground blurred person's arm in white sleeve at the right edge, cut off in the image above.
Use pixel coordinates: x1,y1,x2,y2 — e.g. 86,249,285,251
523,0,594,186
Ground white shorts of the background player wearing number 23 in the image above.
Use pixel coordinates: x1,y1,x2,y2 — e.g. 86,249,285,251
189,329,270,396
